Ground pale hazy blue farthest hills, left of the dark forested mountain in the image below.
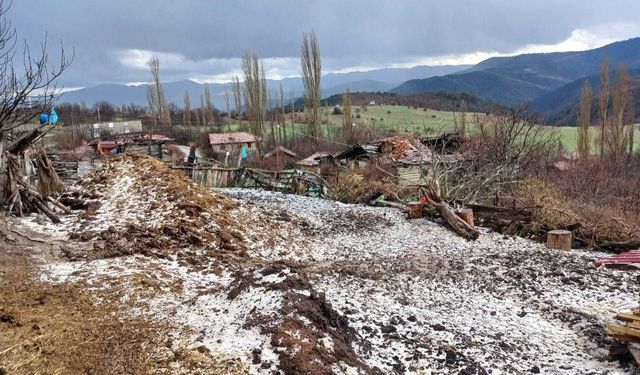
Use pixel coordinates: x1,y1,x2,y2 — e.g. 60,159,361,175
60,65,470,109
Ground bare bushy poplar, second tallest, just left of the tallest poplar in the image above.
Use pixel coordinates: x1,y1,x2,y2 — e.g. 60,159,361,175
242,51,267,150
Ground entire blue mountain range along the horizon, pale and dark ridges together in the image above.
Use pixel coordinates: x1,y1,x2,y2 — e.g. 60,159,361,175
62,38,640,124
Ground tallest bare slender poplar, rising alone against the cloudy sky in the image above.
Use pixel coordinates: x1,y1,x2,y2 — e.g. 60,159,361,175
300,31,322,148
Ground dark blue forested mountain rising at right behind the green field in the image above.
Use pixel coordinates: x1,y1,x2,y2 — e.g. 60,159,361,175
391,38,640,104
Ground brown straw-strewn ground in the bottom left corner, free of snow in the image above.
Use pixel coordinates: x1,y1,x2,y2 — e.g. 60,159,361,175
0,254,248,375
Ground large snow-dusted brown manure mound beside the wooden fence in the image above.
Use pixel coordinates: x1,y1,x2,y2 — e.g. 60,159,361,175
60,154,244,258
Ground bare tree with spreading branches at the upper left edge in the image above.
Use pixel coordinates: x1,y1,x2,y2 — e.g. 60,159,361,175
0,0,73,138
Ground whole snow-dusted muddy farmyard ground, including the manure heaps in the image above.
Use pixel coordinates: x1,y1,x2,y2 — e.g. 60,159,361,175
0,155,640,374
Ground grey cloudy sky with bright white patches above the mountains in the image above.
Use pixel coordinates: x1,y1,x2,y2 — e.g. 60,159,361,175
4,0,640,89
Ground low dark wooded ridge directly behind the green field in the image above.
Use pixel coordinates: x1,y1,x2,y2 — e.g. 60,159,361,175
322,91,499,112
